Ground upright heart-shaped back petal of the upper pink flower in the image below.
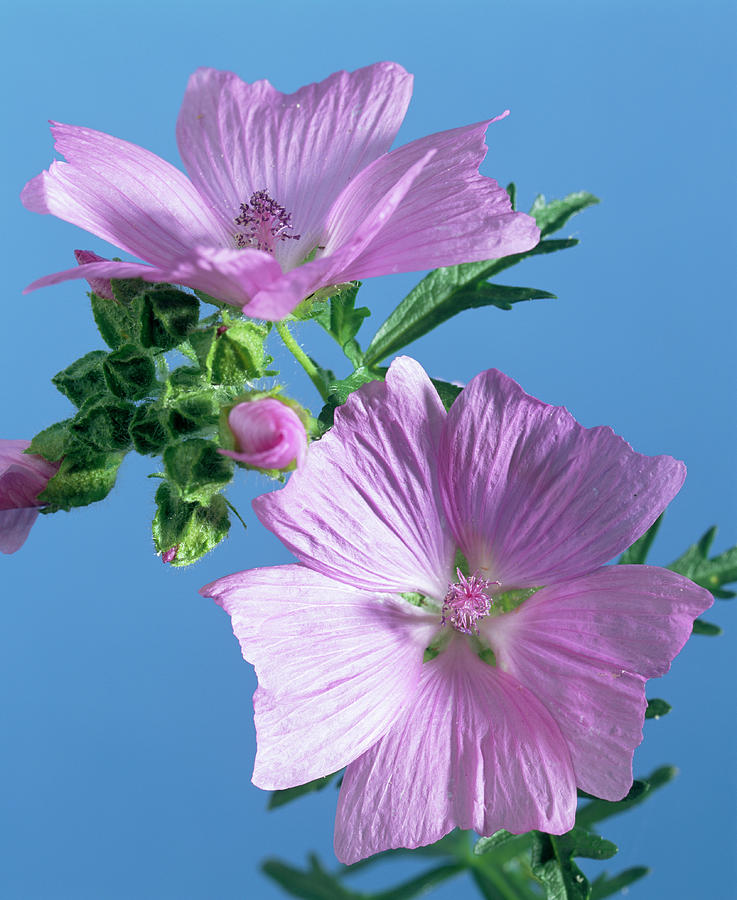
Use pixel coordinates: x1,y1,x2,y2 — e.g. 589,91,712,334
177,63,412,268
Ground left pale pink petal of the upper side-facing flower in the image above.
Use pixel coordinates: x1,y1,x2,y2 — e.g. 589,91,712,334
21,123,232,266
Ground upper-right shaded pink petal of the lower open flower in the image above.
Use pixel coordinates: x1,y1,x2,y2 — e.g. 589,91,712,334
439,369,686,587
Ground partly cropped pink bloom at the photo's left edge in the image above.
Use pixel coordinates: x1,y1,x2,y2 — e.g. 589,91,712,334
0,438,59,553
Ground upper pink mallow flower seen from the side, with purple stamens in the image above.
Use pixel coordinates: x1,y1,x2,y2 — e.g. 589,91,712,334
21,62,539,320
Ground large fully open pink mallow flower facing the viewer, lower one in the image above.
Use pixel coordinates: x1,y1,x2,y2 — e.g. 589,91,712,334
202,358,712,863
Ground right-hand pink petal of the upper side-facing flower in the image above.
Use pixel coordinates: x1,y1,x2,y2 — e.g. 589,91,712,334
325,117,540,281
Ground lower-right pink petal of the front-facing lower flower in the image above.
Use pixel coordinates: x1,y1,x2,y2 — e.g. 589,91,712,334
481,566,713,800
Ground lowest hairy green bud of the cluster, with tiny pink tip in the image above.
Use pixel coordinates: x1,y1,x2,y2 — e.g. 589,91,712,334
152,482,230,566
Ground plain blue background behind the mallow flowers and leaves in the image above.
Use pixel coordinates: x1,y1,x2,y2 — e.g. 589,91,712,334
0,0,737,900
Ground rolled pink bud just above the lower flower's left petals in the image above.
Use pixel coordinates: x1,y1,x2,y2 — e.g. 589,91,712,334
218,397,307,469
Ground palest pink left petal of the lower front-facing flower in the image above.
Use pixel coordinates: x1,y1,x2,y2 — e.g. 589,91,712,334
201,566,437,790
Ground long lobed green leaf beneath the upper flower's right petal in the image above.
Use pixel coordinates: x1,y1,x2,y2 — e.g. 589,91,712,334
363,192,598,367
